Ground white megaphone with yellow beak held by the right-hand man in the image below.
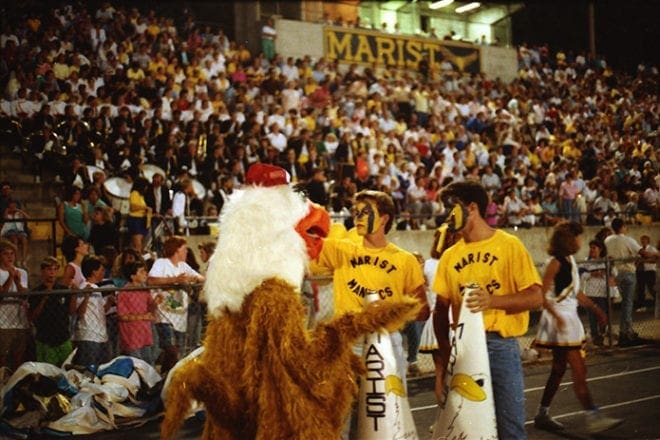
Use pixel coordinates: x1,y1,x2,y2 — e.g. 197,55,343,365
433,284,497,440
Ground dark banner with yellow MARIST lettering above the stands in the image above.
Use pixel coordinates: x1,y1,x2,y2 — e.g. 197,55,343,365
323,26,481,73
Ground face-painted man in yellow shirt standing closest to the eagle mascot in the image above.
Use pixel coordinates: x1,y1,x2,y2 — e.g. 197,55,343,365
313,190,430,379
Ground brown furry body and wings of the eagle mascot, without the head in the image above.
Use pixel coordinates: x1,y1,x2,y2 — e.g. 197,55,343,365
162,279,419,440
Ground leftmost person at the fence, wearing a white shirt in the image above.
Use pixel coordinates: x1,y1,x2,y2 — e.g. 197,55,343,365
0,239,31,371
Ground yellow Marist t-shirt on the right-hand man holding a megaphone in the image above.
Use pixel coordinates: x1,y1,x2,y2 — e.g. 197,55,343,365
433,230,541,338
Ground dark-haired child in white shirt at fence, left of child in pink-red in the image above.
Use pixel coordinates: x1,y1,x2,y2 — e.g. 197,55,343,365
73,255,114,367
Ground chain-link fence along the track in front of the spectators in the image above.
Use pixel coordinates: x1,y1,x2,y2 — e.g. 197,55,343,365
0,260,660,373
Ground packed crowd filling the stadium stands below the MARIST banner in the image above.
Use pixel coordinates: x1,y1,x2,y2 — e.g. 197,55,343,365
0,3,658,237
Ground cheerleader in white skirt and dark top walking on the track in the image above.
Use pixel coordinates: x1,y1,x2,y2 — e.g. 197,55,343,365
534,222,623,433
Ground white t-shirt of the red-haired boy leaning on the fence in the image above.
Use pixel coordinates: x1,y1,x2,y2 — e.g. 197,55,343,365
149,258,200,332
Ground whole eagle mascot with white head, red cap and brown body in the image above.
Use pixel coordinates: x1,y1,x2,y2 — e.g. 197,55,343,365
161,164,419,440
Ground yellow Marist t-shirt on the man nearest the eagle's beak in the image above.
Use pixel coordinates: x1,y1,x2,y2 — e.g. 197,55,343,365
313,238,424,316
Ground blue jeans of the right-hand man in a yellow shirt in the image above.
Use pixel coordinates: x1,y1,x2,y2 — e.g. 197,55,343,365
486,333,527,440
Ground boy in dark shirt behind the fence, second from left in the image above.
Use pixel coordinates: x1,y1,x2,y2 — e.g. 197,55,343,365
28,257,76,367
